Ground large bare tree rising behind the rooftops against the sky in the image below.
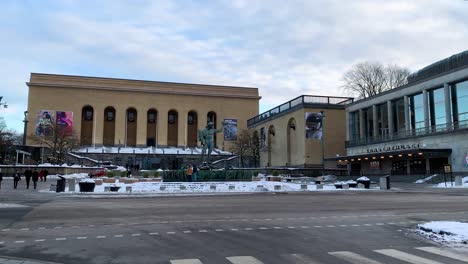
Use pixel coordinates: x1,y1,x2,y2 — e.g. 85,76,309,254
343,61,410,98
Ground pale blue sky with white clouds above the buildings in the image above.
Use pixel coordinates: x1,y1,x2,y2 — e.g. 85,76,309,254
0,0,468,132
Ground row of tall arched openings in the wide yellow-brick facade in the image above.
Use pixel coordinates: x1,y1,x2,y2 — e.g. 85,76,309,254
80,106,217,147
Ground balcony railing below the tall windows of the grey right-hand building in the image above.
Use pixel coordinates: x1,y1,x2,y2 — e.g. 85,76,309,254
346,120,468,147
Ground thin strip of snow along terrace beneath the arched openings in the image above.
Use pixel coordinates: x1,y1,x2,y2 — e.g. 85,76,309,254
75,147,232,155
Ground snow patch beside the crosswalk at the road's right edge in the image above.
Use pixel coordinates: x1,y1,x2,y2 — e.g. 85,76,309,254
418,221,468,246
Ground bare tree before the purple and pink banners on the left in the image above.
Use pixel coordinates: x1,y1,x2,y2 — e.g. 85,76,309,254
30,122,79,163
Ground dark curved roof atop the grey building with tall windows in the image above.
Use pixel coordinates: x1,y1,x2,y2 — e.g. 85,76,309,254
408,50,468,84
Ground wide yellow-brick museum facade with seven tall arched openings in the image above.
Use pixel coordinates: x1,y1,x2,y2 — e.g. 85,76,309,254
26,73,260,150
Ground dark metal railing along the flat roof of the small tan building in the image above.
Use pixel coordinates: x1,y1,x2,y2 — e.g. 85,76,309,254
247,95,354,126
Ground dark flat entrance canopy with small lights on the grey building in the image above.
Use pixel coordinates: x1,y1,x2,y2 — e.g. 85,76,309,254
325,149,452,162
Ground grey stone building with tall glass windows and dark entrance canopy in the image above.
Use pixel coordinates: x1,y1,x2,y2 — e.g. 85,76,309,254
331,51,468,175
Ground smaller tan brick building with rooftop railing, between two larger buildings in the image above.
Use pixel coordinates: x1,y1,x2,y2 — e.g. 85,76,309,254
247,95,353,168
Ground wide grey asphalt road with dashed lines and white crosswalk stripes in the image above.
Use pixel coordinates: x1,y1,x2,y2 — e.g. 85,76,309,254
0,178,468,264
